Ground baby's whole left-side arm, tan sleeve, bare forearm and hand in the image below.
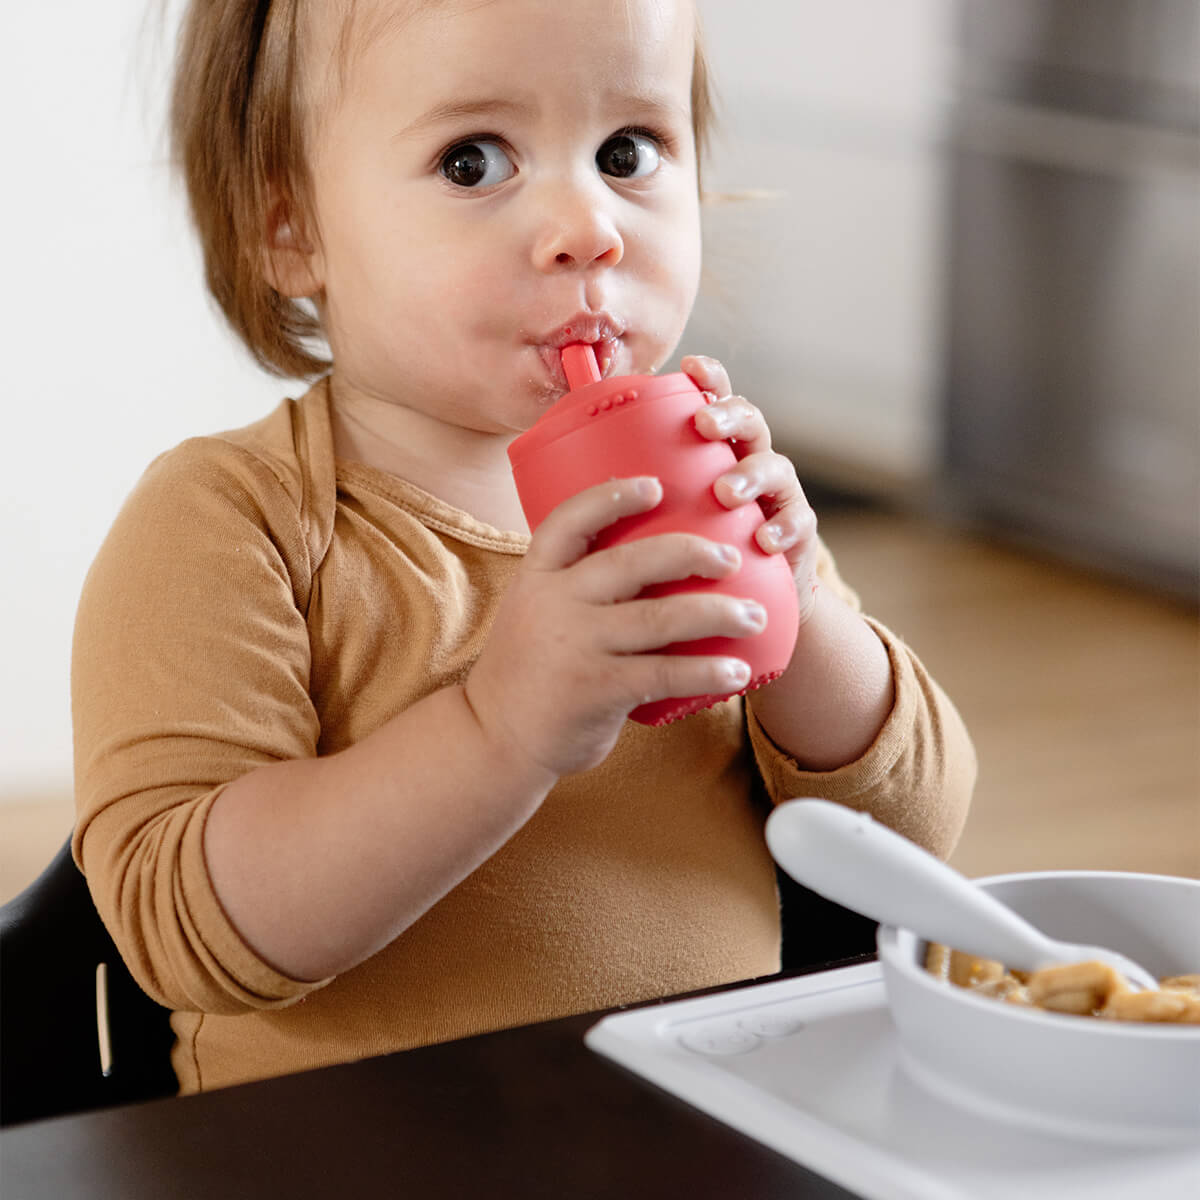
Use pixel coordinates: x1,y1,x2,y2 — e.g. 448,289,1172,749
73,439,752,1012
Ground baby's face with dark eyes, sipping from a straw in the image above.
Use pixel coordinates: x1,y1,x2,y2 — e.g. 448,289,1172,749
296,0,700,433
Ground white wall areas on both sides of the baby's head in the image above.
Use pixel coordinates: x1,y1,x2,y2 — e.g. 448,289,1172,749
0,0,950,800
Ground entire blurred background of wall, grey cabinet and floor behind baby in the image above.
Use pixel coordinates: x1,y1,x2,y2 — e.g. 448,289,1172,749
0,0,1200,900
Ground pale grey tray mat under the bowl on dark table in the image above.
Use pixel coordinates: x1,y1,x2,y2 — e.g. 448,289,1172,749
586,964,1200,1200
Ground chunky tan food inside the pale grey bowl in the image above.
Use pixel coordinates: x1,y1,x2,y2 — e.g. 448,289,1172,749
925,942,1200,1025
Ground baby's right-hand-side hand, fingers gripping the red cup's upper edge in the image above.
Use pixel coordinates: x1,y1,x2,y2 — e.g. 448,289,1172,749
680,355,817,625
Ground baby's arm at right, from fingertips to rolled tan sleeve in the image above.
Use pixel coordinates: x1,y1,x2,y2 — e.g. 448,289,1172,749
683,358,976,854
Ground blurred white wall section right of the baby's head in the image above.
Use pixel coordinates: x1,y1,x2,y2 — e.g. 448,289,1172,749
691,0,955,491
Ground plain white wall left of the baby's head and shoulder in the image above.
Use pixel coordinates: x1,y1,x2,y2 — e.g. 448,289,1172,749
0,7,295,799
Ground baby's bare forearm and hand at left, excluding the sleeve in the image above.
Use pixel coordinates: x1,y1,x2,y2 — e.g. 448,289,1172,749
204,480,758,980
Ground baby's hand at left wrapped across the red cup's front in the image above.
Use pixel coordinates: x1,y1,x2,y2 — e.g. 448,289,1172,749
466,478,766,778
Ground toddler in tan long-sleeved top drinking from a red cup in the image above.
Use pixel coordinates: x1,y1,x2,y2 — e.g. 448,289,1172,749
72,0,974,1092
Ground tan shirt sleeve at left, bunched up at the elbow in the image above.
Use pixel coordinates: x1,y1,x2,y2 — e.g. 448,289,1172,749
72,438,328,1013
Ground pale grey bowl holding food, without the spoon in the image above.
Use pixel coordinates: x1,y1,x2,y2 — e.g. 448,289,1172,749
878,871,1200,1144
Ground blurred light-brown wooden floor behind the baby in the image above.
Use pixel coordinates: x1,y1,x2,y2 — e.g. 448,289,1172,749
0,508,1200,901
